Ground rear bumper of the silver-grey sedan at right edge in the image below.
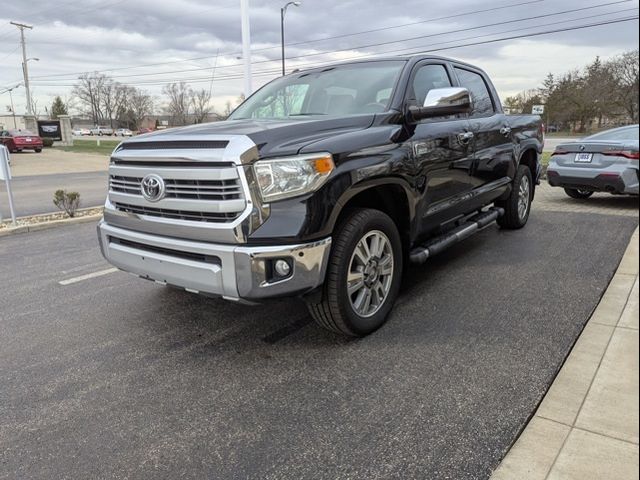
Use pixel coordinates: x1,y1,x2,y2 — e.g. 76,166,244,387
547,162,640,195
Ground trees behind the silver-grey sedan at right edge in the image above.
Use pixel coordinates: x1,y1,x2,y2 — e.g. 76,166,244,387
504,50,639,132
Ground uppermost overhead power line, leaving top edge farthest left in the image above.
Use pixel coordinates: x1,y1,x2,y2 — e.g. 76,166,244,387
28,0,544,78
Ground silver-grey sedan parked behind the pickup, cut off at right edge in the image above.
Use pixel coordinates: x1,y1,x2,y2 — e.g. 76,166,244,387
547,125,640,198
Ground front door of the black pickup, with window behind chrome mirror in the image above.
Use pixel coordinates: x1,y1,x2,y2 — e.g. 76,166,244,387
405,60,473,233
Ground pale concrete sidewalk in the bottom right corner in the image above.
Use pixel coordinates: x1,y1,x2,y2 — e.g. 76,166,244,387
491,229,639,480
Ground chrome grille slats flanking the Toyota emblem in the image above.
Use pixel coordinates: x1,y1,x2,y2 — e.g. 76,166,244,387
109,175,242,200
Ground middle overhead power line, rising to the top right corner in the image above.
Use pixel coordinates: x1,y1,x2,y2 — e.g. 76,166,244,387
28,0,631,81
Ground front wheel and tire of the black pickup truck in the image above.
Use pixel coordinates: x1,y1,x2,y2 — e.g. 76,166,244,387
307,209,403,337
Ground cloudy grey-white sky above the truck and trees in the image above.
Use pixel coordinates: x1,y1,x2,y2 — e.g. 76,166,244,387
0,0,638,113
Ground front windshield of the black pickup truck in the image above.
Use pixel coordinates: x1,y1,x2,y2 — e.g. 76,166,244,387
229,60,405,120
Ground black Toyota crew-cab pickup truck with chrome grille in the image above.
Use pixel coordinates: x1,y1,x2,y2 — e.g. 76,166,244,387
98,55,543,336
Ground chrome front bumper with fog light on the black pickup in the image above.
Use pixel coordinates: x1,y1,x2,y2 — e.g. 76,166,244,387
98,221,331,302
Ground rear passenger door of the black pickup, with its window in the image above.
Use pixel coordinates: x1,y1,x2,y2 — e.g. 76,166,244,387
454,65,516,192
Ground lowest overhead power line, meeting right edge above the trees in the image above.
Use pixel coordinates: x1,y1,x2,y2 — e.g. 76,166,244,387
27,15,638,87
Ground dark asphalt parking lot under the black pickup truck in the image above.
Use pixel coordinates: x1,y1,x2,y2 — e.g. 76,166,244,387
0,189,638,479
